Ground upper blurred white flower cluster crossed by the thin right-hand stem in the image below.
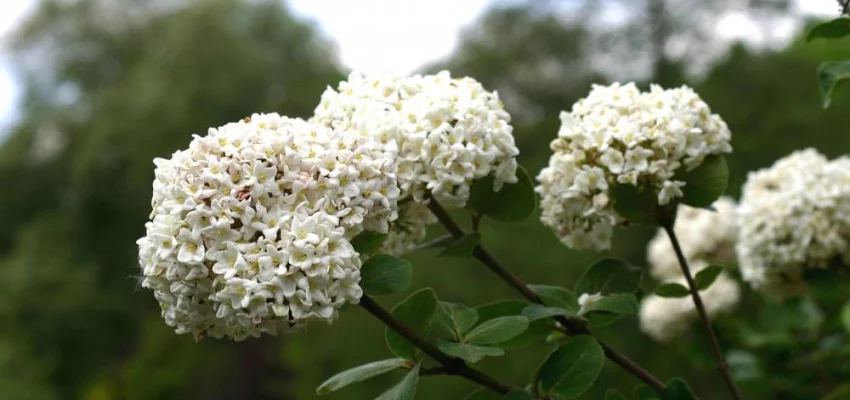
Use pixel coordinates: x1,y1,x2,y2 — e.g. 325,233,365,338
647,196,738,280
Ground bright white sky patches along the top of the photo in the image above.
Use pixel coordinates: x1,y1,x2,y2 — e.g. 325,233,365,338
0,0,837,136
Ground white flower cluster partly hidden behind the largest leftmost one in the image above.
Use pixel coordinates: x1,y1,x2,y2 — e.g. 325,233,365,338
313,71,519,208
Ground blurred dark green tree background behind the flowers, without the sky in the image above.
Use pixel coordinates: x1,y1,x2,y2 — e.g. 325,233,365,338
0,0,850,399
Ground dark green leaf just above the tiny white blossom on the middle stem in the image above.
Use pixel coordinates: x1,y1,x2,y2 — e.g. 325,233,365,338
574,258,641,294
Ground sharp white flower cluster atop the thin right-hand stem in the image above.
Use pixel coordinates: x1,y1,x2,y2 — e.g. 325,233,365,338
536,83,732,250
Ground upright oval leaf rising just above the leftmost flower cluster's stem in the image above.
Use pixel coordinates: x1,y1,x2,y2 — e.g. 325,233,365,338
387,288,437,360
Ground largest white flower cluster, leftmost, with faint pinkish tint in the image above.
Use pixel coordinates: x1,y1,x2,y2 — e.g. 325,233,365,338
138,114,400,340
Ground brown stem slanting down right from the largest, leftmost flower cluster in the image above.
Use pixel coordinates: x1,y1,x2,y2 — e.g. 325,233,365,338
360,294,521,395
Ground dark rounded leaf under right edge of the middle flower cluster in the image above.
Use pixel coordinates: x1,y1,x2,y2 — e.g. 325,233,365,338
466,166,537,222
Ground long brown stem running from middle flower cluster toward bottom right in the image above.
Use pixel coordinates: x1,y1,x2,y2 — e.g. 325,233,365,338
428,198,665,393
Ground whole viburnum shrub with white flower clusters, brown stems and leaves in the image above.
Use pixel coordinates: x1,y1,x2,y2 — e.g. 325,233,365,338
138,24,850,394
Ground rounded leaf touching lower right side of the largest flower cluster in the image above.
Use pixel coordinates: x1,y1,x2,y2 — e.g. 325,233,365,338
360,254,413,296
